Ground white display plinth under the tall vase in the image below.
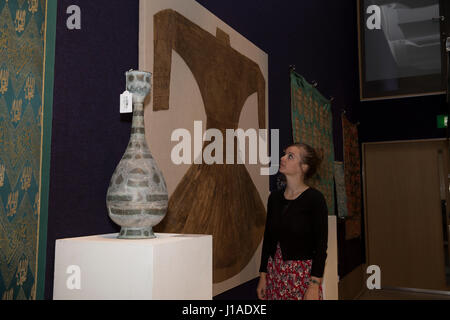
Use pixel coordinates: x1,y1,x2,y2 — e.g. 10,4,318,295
53,234,212,300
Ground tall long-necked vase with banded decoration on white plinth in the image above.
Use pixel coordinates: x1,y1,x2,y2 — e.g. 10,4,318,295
106,71,168,239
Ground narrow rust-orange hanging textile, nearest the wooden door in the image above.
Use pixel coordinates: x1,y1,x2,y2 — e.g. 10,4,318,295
342,114,361,240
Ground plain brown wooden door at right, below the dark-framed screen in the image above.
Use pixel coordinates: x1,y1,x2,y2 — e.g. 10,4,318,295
363,140,449,290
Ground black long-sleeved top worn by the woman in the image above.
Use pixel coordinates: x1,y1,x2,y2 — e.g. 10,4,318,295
259,188,328,278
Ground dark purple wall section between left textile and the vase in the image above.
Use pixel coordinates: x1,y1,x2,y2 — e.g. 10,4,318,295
45,0,139,299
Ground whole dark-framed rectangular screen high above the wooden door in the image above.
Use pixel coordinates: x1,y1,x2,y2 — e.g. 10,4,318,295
358,0,450,100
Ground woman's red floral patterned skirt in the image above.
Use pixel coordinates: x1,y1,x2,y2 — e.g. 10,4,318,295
266,243,323,300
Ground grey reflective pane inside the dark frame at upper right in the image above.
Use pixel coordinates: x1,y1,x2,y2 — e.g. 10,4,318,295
364,0,441,81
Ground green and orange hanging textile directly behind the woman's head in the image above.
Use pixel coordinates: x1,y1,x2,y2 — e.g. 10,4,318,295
291,72,335,215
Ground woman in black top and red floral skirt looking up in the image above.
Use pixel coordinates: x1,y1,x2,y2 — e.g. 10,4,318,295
257,143,328,300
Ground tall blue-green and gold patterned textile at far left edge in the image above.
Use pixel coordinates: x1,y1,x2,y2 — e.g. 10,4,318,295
0,0,56,300
